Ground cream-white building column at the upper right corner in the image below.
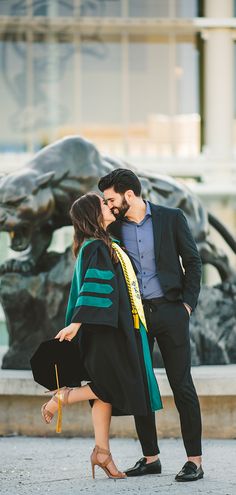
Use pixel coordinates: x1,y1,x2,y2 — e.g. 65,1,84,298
204,0,234,161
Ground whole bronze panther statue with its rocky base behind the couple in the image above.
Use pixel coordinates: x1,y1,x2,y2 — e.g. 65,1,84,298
0,137,236,369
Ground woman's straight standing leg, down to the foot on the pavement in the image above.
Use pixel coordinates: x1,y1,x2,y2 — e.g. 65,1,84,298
92,399,124,476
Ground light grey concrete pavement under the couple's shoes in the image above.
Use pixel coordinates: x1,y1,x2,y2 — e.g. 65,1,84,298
0,436,236,495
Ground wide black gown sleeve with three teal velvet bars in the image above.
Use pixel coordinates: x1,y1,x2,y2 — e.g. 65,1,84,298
66,240,119,327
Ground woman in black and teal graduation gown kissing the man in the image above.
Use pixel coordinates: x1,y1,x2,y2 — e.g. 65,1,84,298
42,193,162,478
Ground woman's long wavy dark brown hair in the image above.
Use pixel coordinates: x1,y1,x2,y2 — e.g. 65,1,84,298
70,193,118,262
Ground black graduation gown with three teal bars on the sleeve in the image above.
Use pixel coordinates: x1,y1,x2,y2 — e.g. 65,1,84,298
66,240,161,415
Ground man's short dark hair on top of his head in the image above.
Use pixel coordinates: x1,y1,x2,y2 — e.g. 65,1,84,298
98,168,141,196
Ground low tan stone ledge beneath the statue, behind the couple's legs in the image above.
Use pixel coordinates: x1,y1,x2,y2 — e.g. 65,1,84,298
0,365,236,438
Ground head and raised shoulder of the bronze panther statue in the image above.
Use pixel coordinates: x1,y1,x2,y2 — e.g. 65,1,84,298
0,136,111,251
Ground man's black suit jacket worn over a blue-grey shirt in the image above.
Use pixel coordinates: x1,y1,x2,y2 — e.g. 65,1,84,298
109,203,201,310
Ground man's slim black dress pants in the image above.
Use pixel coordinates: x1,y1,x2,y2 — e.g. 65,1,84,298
135,297,202,457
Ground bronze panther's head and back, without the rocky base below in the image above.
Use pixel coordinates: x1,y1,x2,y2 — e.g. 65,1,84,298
0,137,236,280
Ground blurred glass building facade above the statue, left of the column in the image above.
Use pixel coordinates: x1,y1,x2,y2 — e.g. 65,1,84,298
0,0,201,157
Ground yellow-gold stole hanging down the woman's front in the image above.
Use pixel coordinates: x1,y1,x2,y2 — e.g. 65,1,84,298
112,242,148,331
